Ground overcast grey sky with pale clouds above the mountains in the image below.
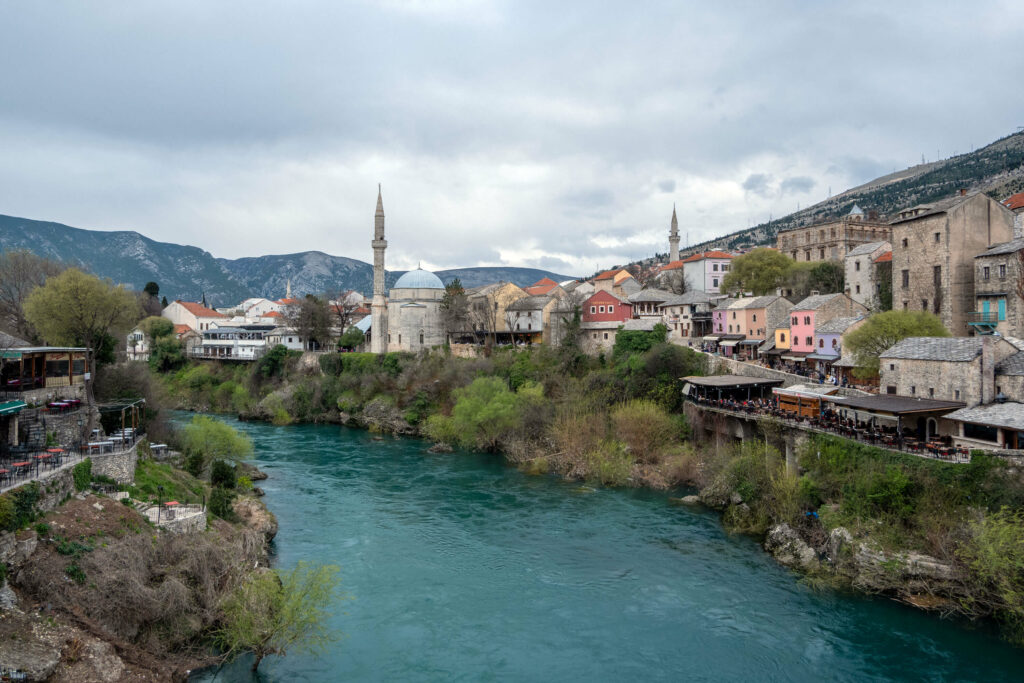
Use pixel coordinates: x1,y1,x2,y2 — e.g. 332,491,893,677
0,0,1024,274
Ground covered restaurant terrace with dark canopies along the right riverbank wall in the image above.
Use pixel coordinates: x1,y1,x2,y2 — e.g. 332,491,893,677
682,375,971,463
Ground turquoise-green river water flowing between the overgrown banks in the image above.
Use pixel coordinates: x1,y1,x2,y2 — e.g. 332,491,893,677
197,421,1024,682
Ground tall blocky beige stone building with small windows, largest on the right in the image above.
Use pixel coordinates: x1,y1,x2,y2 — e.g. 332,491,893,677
891,190,1014,336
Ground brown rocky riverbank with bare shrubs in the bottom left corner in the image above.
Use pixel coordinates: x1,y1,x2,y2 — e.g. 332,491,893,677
0,481,278,683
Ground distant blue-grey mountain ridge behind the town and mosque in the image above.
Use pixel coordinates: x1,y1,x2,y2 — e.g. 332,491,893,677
0,215,571,306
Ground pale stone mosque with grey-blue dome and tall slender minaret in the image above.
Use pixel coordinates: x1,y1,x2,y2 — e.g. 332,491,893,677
370,188,445,353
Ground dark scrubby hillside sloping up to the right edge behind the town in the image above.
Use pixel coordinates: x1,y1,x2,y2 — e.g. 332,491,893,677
685,132,1024,254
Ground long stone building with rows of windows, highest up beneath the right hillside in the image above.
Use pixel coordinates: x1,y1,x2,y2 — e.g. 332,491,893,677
775,205,892,262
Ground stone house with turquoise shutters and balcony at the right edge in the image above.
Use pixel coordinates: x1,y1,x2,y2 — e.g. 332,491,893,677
969,238,1024,337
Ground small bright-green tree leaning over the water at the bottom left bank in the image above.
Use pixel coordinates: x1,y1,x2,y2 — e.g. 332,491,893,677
217,562,340,671
